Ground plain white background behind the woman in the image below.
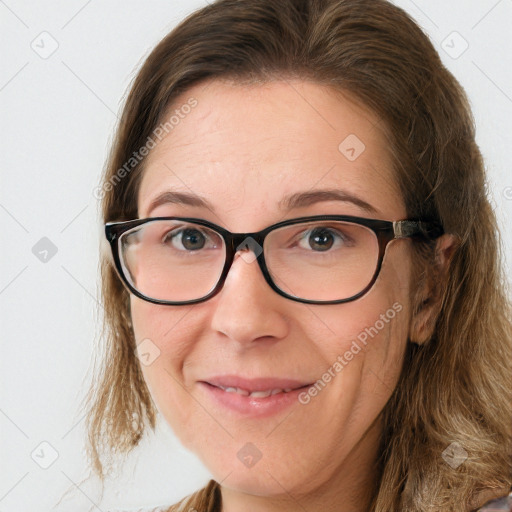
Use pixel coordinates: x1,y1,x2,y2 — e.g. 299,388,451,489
0,0,512,512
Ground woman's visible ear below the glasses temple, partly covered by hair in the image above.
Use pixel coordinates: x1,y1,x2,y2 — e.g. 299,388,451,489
409,233,459,345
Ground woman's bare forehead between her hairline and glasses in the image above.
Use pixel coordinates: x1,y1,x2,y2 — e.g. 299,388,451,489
138,80,405,229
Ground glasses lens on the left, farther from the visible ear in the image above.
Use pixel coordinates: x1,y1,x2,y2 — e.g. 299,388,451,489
119,220,226,302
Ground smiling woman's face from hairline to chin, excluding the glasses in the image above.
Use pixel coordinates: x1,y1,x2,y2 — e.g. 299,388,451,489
131,81,411,496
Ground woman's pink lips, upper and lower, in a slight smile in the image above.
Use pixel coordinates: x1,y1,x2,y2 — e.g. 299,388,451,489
198,375,313,418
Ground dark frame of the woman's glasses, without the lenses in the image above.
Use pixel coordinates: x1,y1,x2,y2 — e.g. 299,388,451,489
105,215,444,306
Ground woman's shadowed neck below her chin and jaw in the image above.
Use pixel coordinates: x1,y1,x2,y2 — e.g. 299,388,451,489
221,415,382,512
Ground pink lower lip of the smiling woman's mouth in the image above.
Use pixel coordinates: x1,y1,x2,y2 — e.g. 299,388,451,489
199,382,310,418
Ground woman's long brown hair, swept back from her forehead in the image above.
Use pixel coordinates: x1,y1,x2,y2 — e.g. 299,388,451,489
83,0,512,512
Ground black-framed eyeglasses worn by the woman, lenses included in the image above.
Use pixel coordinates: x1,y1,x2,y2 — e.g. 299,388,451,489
105,215,443,305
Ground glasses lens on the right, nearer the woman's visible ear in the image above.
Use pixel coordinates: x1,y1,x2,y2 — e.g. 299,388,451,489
264,221,379,301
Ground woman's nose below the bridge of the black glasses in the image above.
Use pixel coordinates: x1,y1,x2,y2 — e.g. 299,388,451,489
207,251,291,345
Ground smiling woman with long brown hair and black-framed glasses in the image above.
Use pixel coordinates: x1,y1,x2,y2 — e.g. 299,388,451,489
82,0,512,512
